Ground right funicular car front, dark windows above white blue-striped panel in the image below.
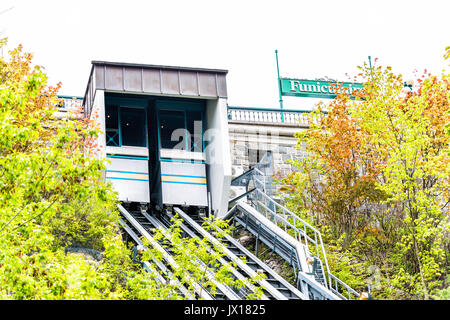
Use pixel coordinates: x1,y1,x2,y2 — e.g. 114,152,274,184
156,100,208,207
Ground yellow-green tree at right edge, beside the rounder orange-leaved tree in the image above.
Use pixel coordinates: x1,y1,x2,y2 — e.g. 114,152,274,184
354,58,450,299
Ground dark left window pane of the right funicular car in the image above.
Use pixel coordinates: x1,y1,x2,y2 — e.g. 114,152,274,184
159,110,185,150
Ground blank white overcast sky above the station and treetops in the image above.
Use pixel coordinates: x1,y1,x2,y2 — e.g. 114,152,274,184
0,0,450,109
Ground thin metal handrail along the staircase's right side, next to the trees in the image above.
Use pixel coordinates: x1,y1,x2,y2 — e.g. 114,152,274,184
249,168,360,300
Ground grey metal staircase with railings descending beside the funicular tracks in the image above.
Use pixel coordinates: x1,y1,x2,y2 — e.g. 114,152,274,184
224,152,360,299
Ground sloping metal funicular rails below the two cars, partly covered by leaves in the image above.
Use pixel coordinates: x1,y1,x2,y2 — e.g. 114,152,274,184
119,206,307,300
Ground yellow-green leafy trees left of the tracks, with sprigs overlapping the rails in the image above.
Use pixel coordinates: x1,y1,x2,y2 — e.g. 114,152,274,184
0,40,257,299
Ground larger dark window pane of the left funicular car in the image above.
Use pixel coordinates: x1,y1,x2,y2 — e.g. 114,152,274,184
120,108,147,147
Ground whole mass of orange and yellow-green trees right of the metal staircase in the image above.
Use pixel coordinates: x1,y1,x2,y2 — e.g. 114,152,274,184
281,49,450,299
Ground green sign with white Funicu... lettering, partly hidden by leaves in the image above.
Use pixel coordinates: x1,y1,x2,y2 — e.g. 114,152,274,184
280,78,364,99
